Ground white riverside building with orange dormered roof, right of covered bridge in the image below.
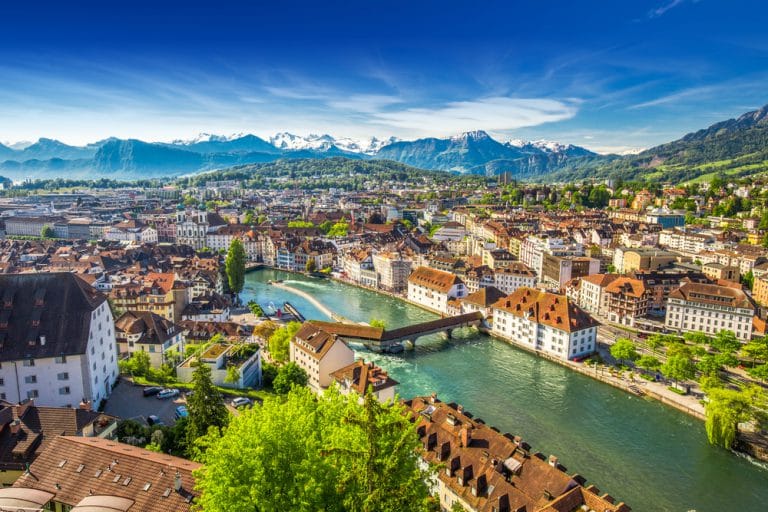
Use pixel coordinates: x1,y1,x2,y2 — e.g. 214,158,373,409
492,288,598,360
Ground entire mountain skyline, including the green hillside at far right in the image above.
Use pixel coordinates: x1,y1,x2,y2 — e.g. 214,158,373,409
0,106,768,183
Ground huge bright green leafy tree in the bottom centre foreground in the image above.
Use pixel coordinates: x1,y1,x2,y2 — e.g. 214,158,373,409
195,388,428,512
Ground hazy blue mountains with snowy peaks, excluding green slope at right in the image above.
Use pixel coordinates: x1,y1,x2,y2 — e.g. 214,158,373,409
0,131,595,180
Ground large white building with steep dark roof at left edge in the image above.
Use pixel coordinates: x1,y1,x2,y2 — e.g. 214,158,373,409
0,273,118,408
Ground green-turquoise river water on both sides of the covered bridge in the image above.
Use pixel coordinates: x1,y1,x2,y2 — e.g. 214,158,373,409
242,270,768,512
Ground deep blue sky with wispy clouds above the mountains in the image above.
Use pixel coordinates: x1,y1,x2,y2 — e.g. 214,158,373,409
0,0,768,151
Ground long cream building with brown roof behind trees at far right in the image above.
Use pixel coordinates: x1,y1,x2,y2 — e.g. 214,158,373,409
665,283,755,341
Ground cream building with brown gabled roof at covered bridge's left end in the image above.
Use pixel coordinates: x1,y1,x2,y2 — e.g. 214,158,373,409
291,321,355,393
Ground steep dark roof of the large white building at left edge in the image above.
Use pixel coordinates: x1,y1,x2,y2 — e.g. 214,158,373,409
0,272,106,361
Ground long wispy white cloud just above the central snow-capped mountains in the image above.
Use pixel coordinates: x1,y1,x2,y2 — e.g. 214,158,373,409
371,97,578,135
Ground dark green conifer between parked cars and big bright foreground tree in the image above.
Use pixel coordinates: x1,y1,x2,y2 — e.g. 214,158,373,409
187,363,229,460
